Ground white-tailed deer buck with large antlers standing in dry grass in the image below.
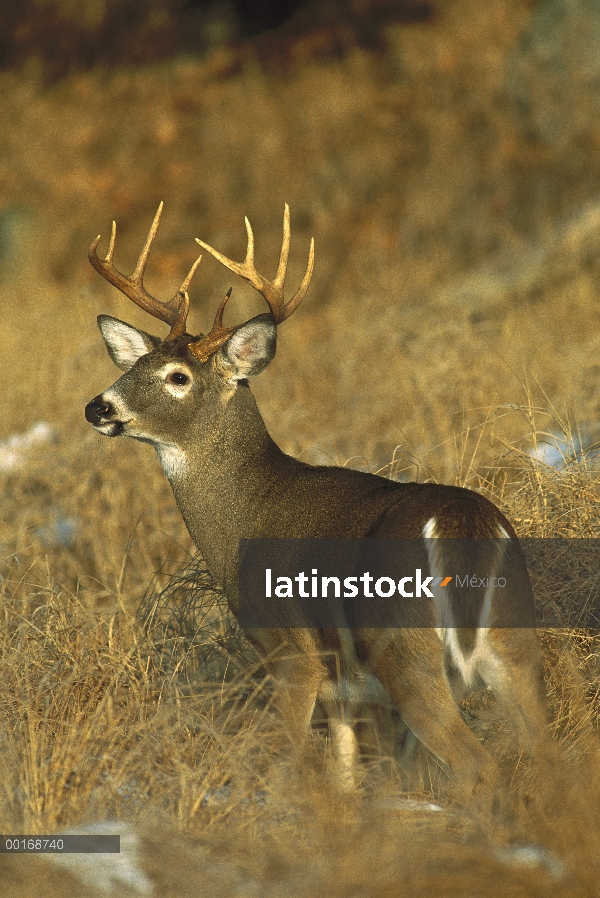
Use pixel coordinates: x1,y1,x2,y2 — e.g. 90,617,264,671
85,204,547,804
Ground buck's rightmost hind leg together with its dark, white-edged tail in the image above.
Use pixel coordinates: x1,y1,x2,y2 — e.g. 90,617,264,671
423,509,547,751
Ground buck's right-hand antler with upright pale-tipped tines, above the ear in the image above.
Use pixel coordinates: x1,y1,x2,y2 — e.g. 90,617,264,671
196,203,314,324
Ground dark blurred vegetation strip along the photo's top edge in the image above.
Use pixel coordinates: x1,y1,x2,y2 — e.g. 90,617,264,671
0,0,433,80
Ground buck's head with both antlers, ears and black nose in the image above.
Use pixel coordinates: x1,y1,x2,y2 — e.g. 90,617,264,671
85,203,314,458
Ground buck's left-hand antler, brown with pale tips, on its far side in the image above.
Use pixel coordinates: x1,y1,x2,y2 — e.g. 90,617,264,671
88,203,202,340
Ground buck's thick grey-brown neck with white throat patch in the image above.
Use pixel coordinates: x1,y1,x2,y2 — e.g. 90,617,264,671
156,385,286,590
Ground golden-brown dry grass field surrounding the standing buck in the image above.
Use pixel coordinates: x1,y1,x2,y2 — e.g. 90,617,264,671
0,0,600,898
